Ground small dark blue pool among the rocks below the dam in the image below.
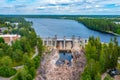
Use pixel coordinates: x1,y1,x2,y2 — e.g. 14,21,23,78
56,53,72,66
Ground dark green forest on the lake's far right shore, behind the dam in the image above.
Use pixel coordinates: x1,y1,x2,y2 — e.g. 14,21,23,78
76,18,120,34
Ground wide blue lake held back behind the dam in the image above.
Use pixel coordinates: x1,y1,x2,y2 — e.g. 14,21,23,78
26,18,120,43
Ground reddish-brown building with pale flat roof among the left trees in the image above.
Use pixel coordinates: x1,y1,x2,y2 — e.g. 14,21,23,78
0,34,21,45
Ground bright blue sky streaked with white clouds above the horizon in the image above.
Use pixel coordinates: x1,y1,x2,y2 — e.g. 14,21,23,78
0,0,120,15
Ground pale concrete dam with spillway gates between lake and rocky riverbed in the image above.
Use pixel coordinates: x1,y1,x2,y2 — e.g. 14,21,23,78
42,35,88,50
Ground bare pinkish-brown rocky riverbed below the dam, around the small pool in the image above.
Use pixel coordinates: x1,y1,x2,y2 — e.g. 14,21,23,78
35,50,86,80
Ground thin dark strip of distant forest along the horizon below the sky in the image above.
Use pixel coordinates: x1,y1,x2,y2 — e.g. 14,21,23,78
0,15,120,18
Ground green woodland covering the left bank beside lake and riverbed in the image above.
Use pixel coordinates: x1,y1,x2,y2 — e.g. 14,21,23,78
0,17,43,80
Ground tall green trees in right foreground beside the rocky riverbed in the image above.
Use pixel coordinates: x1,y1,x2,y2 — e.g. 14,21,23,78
81,36,120,80
